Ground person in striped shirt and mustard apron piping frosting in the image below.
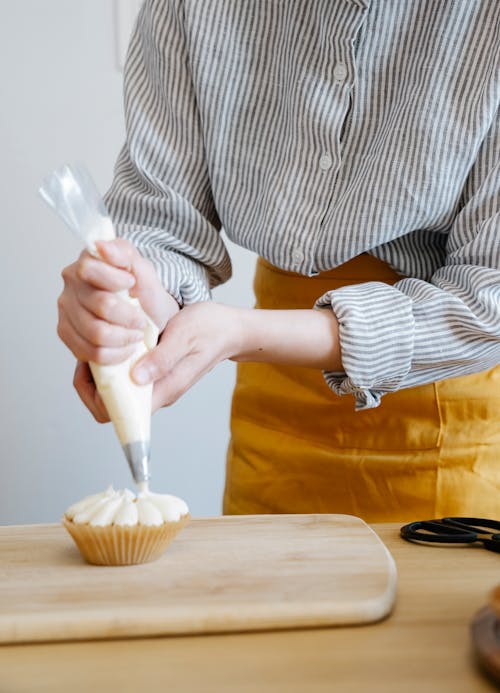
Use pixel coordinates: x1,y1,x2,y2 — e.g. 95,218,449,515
58,0,500,521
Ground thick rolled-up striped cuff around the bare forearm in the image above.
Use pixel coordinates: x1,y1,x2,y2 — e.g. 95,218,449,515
315,282,415,410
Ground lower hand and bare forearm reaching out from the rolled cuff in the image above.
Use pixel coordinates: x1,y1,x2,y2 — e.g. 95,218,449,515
132,302,342,411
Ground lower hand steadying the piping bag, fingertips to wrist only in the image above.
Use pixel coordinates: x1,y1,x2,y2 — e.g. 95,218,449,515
132,301,241,411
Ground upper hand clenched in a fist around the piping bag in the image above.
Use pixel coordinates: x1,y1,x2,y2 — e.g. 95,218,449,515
57,239,179,421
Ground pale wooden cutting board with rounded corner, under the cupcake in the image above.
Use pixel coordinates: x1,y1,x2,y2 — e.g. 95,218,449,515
0,515,396,643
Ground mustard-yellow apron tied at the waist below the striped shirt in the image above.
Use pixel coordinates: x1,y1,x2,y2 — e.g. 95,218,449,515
224,255,500,522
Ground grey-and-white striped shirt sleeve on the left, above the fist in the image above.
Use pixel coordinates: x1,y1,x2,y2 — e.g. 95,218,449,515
105,0,231,304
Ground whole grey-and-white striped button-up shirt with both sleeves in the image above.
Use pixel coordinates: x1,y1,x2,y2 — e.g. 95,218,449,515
106,0,500,409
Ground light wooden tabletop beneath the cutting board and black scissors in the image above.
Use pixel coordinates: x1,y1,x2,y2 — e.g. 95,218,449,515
0,524,500,693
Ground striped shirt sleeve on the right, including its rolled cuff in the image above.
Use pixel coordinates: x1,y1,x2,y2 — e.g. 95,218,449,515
316,113,500,409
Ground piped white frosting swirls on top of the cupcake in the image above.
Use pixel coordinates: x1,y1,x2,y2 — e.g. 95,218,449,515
65,486,189,527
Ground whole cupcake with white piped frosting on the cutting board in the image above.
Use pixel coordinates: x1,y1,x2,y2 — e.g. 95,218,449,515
62,486,189,565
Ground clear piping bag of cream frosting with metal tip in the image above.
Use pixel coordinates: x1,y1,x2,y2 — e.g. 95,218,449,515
39,165,158,490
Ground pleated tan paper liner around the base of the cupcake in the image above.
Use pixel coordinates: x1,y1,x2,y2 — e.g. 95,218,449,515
62,515,189,565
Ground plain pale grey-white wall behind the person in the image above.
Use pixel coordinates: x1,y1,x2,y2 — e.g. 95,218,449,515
0,0,254,524
